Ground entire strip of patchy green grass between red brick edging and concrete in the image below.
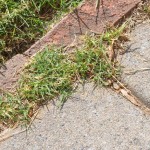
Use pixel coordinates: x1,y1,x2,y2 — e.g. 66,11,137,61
0,27,124,125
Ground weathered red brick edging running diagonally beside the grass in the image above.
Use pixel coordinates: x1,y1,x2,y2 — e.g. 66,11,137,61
0,0,141,91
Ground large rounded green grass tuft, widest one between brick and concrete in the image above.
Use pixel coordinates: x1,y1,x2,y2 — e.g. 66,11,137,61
19,48,75,103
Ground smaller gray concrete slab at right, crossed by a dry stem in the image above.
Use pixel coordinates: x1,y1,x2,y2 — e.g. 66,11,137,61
121,22,150,105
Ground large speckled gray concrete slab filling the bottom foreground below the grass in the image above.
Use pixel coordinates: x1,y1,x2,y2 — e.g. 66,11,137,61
0,84,150,150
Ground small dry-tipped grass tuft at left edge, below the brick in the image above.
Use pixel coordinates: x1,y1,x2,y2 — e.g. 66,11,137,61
0,93,30,127
